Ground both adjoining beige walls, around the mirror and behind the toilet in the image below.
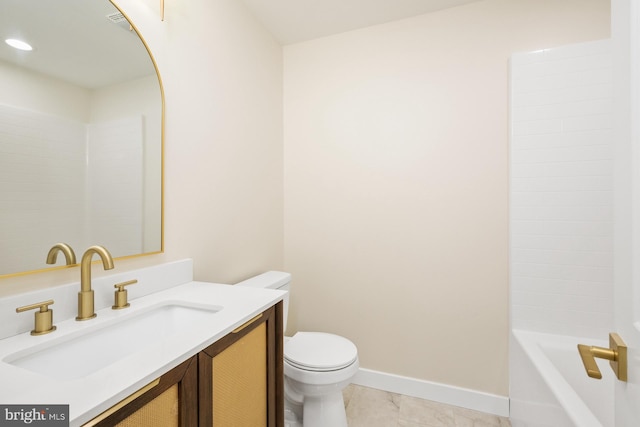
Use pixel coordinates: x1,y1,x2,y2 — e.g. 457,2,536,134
0,0,609,402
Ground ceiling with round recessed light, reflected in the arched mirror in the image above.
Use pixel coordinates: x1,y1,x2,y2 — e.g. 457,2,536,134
0,0,155,89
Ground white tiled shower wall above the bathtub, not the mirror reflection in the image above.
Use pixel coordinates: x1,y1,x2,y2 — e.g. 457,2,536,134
510,40,613,338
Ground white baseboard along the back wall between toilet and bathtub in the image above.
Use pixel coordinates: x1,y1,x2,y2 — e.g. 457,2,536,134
352,368,509,417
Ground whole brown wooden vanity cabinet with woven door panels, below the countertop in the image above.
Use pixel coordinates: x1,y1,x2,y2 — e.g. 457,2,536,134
83,302,284,427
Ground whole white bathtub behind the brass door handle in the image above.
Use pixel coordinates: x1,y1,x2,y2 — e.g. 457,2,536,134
509,330,614,427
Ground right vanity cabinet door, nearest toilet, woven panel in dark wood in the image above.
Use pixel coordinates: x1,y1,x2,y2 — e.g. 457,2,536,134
198,303,284,427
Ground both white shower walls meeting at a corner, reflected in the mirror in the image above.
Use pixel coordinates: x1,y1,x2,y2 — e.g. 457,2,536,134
0,105,143,274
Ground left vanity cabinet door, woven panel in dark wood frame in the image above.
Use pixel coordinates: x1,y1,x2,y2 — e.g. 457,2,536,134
83,356,198,427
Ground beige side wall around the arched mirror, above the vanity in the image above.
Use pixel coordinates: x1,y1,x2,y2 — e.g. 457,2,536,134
0,0,283,295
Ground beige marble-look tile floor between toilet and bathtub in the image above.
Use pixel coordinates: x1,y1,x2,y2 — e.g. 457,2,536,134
344,384,511,427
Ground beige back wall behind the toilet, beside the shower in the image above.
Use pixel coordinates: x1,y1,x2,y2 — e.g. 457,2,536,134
284,0,609,395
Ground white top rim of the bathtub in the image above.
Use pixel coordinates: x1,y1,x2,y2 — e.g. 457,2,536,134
511,329,608,427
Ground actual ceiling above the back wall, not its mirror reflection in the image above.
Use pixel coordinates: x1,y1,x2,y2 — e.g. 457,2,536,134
243,0,478,45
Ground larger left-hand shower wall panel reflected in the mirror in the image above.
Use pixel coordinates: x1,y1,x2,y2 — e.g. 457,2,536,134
0,105,86,274
